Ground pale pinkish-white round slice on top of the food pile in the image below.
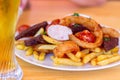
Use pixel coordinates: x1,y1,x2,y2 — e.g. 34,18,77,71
47,25,72,40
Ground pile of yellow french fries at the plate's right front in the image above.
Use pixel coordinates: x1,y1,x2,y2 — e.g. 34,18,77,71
51,47,120,66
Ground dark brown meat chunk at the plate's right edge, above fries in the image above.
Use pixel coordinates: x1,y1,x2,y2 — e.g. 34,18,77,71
103,37,119,51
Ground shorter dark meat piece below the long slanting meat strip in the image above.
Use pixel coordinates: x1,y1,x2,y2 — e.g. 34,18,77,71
24,35,47,46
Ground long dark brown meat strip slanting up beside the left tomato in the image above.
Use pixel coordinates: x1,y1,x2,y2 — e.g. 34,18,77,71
15,21,48,40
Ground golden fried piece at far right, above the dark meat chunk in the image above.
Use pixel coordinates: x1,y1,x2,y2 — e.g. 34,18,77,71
102,27,120,38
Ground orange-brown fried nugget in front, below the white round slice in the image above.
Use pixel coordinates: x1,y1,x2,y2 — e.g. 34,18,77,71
53,41,80,58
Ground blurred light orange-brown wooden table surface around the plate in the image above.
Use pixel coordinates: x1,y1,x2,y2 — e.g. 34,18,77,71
17,0,120,80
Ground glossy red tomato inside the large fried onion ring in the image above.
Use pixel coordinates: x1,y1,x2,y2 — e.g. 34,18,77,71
75,30,95,43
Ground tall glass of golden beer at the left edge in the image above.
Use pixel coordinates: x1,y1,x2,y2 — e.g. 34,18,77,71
0,0,22,80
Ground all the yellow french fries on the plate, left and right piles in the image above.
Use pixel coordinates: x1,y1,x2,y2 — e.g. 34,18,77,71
15,28,120,66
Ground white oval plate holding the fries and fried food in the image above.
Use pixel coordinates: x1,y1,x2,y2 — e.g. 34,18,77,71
15,14,120,71
